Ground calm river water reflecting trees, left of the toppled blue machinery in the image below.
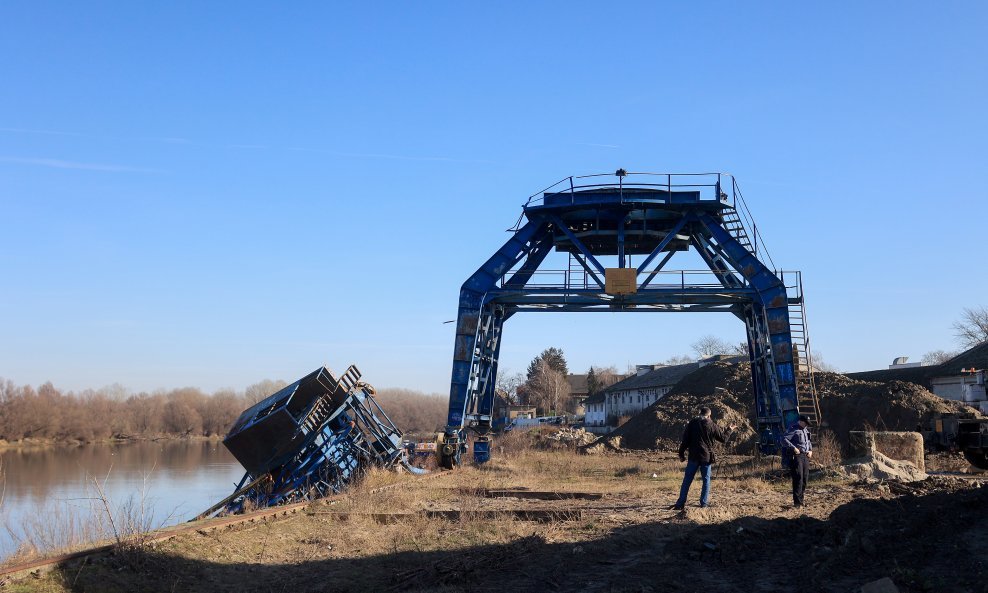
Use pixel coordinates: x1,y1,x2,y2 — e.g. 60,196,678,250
0,438,244,561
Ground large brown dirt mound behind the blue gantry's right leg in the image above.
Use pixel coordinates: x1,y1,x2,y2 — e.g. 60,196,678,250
585,362,971,453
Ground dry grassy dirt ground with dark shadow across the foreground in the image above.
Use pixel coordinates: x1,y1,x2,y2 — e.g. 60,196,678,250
0,443,988,593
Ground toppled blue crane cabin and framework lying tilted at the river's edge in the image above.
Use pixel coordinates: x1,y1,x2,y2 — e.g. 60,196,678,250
200,365,404,517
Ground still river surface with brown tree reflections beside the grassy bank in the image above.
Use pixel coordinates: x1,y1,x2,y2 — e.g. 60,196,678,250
0,441,244,558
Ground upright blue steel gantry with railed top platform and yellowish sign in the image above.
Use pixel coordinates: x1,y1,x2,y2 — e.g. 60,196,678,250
440,170,820,468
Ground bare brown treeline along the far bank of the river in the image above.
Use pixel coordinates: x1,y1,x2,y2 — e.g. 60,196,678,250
0,379,447,442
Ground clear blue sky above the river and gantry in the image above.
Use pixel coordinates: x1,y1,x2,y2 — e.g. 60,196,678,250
0,2,988,393
